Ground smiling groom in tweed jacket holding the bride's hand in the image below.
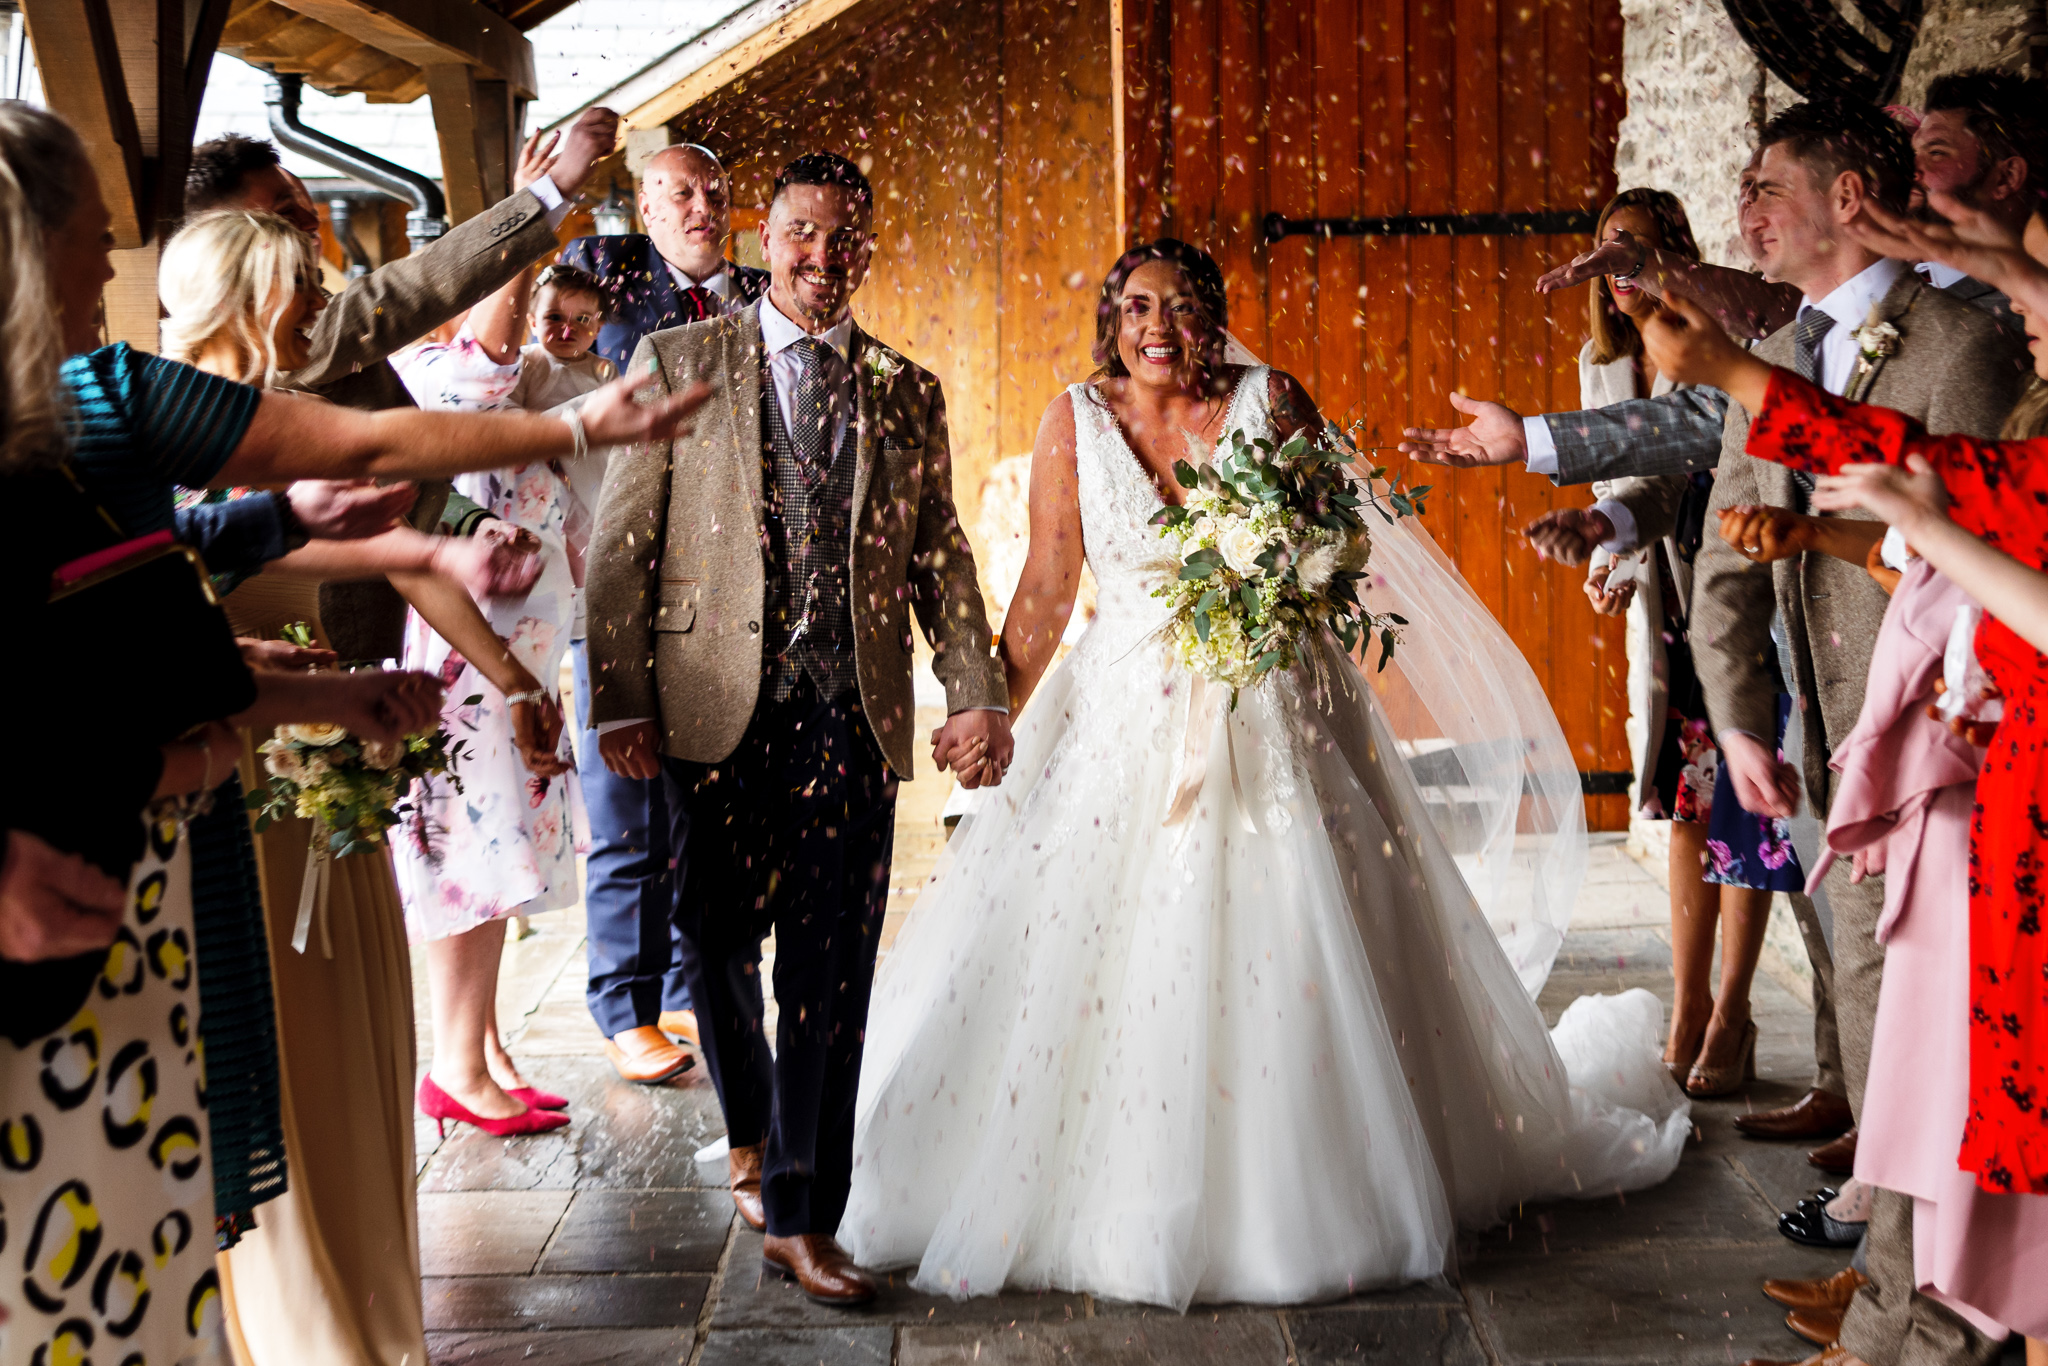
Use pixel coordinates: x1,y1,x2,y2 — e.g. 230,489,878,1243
590,152,1010,1305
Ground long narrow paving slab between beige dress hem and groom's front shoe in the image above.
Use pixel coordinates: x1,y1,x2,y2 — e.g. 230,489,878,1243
422,1276,711,1331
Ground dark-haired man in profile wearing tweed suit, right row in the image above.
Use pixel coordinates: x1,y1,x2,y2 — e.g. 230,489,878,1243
1646,102,2019,1362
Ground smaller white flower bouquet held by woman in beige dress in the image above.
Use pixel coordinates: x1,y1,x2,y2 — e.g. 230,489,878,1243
248,627,481,858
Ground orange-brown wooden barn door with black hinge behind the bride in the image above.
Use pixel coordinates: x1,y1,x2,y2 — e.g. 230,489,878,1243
1112,0,1630,829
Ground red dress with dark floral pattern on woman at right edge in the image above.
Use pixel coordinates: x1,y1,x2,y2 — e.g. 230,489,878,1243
1749,371,2048,1194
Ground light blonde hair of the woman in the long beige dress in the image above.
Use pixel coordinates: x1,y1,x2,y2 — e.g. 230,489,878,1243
156,209,319,389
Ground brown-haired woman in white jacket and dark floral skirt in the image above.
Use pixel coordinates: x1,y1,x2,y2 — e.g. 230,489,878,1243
1528,188,1798,1098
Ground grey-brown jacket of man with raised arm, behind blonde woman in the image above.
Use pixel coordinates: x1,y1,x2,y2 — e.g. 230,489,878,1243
283,190,555,659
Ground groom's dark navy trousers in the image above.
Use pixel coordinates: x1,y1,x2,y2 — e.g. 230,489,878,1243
662,678,897,1237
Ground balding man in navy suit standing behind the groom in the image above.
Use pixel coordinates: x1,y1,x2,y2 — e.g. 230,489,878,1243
561,143,768,1081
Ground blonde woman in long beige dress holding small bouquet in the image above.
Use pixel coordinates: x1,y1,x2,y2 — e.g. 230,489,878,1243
160,211,692,1366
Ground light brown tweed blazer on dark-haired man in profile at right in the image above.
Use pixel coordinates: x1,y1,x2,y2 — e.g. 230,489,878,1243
1692,272,2028,815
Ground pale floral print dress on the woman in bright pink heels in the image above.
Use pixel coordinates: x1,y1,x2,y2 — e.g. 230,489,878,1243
391,326,580,944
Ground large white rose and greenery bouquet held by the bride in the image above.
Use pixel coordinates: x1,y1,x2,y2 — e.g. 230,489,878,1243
1153,428,1430,705
